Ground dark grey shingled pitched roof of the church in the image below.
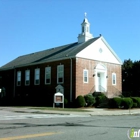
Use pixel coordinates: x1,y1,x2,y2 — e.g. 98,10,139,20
0,37,99,70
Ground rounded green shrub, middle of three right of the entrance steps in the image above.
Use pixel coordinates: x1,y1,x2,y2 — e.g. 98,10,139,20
122,97,133,109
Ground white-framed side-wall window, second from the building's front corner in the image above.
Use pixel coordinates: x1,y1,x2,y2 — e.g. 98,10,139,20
45,67,51,84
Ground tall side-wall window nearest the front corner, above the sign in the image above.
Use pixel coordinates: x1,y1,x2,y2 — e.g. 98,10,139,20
57,65,64,83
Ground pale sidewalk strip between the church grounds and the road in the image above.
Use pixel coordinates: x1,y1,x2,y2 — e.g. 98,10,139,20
0,107,140,116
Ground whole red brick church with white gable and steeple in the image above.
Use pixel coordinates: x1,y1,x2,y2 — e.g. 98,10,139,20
0,17,122,103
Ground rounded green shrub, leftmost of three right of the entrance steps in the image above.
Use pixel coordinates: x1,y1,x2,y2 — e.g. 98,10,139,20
109,97,122,108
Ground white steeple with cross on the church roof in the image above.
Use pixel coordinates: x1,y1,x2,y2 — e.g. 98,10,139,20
78,13,93,43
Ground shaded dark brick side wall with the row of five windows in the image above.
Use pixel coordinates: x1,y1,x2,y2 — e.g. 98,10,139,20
16,59,75,102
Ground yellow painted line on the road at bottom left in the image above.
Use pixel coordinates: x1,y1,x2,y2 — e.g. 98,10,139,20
0,132,62,140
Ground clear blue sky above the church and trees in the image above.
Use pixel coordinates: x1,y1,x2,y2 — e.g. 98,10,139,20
0,0,140,66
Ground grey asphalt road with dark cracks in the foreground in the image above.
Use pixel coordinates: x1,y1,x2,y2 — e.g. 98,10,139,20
0,111,140,140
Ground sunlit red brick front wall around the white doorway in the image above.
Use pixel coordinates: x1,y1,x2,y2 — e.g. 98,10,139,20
76,58,122,97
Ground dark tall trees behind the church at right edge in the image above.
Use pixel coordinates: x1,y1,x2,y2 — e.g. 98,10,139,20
122,59,140,96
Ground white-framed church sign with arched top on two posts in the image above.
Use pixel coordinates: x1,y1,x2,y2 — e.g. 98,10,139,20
53,92,64,108
